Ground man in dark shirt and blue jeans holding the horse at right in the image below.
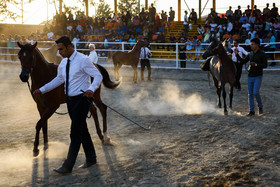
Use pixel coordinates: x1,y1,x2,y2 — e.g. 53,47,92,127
234,38,267,116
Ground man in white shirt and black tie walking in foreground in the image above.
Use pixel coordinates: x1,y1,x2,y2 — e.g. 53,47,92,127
33,36,103,174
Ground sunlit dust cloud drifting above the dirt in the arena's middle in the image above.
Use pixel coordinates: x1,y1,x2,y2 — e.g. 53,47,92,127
124,81,218,115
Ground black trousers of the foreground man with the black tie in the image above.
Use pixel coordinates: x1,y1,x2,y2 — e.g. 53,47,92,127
63,95,96,170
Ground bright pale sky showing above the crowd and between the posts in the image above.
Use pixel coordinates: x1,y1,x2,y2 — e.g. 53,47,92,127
1,0,280,24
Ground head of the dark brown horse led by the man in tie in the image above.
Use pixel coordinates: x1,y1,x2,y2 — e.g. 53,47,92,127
17,42,37,82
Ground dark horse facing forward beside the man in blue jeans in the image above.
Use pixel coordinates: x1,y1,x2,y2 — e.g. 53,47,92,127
204,40,236,115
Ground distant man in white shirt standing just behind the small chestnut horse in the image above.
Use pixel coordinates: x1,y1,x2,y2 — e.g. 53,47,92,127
140,41,152,81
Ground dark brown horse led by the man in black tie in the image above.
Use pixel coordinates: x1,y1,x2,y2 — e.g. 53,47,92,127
17,42,120,156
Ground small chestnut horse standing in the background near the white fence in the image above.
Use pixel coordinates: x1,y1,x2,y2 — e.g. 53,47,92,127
108,41,145,82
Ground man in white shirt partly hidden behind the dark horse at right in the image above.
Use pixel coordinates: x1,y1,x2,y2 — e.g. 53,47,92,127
231,40,248,90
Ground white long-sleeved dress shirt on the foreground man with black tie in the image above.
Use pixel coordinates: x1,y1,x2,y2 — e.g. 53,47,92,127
40,51,103,96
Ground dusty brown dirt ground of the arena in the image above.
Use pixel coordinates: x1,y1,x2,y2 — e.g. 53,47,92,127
0,64,280,187
